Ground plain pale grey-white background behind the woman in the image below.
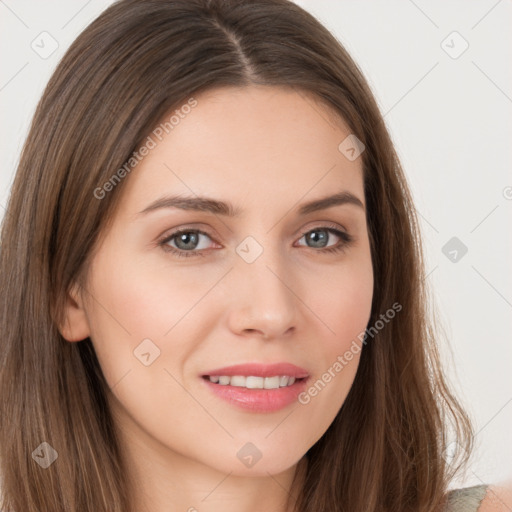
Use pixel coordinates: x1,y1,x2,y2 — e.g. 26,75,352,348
0,0,512,486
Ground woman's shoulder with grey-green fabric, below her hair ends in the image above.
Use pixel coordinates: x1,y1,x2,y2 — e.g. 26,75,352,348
443,484,512,512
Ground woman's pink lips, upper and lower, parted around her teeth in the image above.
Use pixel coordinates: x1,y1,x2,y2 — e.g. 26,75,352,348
202,363,309,413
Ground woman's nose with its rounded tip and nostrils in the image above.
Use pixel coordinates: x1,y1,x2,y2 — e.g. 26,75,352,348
229,247,300,340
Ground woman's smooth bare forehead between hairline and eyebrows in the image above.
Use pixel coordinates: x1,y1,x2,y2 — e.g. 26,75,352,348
117,86,362,218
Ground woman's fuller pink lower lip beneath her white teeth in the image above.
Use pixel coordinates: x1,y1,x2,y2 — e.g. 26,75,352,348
202,377,308,412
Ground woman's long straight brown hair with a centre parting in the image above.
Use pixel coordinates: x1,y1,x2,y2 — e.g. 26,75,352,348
0,0,472,512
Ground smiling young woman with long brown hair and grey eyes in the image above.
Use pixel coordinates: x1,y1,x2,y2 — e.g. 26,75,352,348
0,0,505,512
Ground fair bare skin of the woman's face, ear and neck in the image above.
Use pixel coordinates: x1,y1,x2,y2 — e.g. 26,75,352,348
61,86,373,512
